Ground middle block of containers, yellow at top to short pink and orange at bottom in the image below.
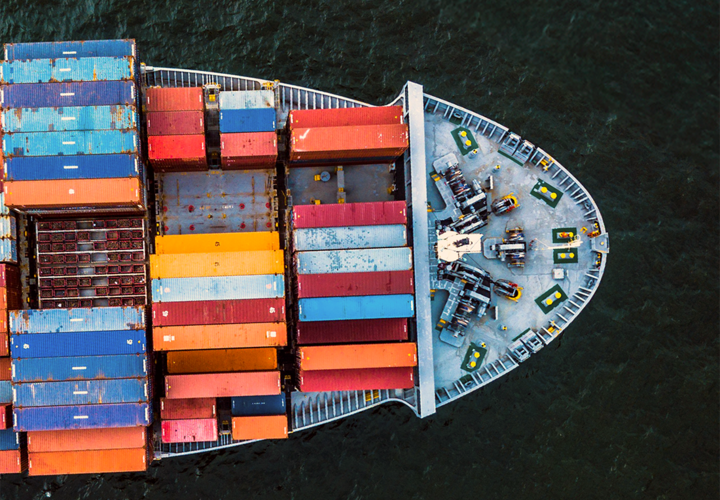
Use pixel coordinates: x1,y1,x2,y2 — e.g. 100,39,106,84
150,232,287,443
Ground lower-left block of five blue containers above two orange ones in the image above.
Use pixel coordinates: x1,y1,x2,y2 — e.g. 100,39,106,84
10,307,152,475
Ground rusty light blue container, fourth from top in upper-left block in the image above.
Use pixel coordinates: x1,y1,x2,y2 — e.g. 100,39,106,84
2,105,137,134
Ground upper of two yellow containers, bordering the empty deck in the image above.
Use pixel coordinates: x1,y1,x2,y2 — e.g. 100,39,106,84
155,231,280,254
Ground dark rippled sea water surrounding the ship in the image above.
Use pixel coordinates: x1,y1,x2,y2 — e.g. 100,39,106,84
0,0,720,500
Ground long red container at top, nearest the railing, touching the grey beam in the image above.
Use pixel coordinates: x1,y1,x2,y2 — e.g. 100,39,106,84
288,106,403,129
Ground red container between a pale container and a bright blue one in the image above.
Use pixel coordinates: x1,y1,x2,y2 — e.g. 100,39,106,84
297,271,414,298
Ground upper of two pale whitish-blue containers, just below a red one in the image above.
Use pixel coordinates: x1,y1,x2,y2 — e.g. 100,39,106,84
293,224,407,252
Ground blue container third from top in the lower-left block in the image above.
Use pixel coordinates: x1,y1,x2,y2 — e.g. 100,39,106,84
12,354,148,384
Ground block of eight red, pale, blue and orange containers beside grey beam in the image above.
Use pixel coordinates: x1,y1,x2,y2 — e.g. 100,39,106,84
293,201,417,392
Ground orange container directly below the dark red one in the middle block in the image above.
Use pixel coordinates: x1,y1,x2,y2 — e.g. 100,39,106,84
153,323,287,351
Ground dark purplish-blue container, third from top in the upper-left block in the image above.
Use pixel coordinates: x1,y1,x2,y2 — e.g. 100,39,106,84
0,81,137,108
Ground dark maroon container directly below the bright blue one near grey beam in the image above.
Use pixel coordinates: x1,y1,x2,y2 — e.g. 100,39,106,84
297,318,408,345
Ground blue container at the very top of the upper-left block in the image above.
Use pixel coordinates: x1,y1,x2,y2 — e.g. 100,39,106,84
5,40,136,60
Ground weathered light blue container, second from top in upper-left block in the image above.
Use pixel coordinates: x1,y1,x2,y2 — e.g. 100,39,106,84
0,57,135,84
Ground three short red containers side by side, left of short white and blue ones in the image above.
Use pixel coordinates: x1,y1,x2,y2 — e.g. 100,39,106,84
145,87,207,172
